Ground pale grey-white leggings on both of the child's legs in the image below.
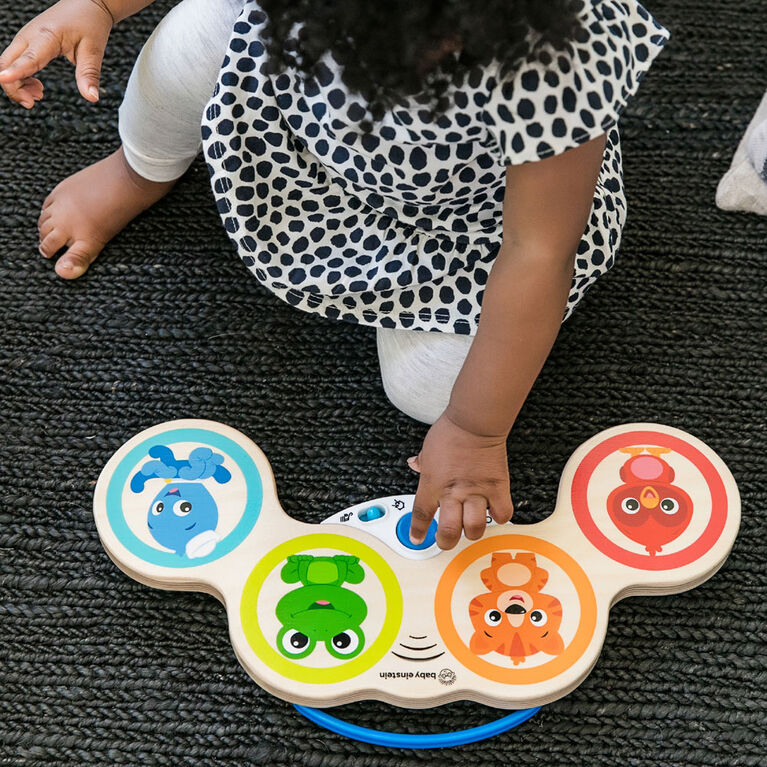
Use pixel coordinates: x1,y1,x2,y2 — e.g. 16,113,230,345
119,0,472,423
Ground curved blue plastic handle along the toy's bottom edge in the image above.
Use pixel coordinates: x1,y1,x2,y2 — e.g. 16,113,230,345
294,703,541,748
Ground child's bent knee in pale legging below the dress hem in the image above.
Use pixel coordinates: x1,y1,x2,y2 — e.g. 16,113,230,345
376,328,473,423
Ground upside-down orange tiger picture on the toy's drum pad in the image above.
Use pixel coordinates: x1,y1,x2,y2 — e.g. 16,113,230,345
469,552,565,666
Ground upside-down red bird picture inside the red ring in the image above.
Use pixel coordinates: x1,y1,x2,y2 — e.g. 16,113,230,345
607,447,692,556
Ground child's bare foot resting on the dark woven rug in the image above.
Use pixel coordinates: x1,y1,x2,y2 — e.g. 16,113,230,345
37,148,176,280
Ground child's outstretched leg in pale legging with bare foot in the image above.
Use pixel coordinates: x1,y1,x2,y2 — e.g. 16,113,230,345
38,0,242,278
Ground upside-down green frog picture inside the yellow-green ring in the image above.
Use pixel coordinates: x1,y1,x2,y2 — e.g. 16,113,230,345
275,554,368,659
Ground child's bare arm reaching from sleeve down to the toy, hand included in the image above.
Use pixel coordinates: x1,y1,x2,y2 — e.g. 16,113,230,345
411,136,605,548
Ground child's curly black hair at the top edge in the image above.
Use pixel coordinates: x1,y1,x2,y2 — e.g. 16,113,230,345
260,0,583,130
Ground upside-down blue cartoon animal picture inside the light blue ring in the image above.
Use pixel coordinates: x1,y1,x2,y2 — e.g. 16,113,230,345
130,445,232,559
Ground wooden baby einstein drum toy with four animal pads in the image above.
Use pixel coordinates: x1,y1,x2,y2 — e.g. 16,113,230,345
94,420,740,709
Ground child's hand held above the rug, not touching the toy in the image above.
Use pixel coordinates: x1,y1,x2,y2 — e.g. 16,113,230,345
0,0,113,109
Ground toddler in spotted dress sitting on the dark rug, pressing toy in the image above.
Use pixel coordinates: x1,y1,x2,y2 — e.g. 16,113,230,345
0,0,668,548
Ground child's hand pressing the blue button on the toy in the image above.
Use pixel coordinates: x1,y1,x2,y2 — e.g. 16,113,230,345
408,415,514,549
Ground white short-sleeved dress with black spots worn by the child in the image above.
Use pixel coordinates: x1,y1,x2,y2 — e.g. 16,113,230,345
202,0,668,335
